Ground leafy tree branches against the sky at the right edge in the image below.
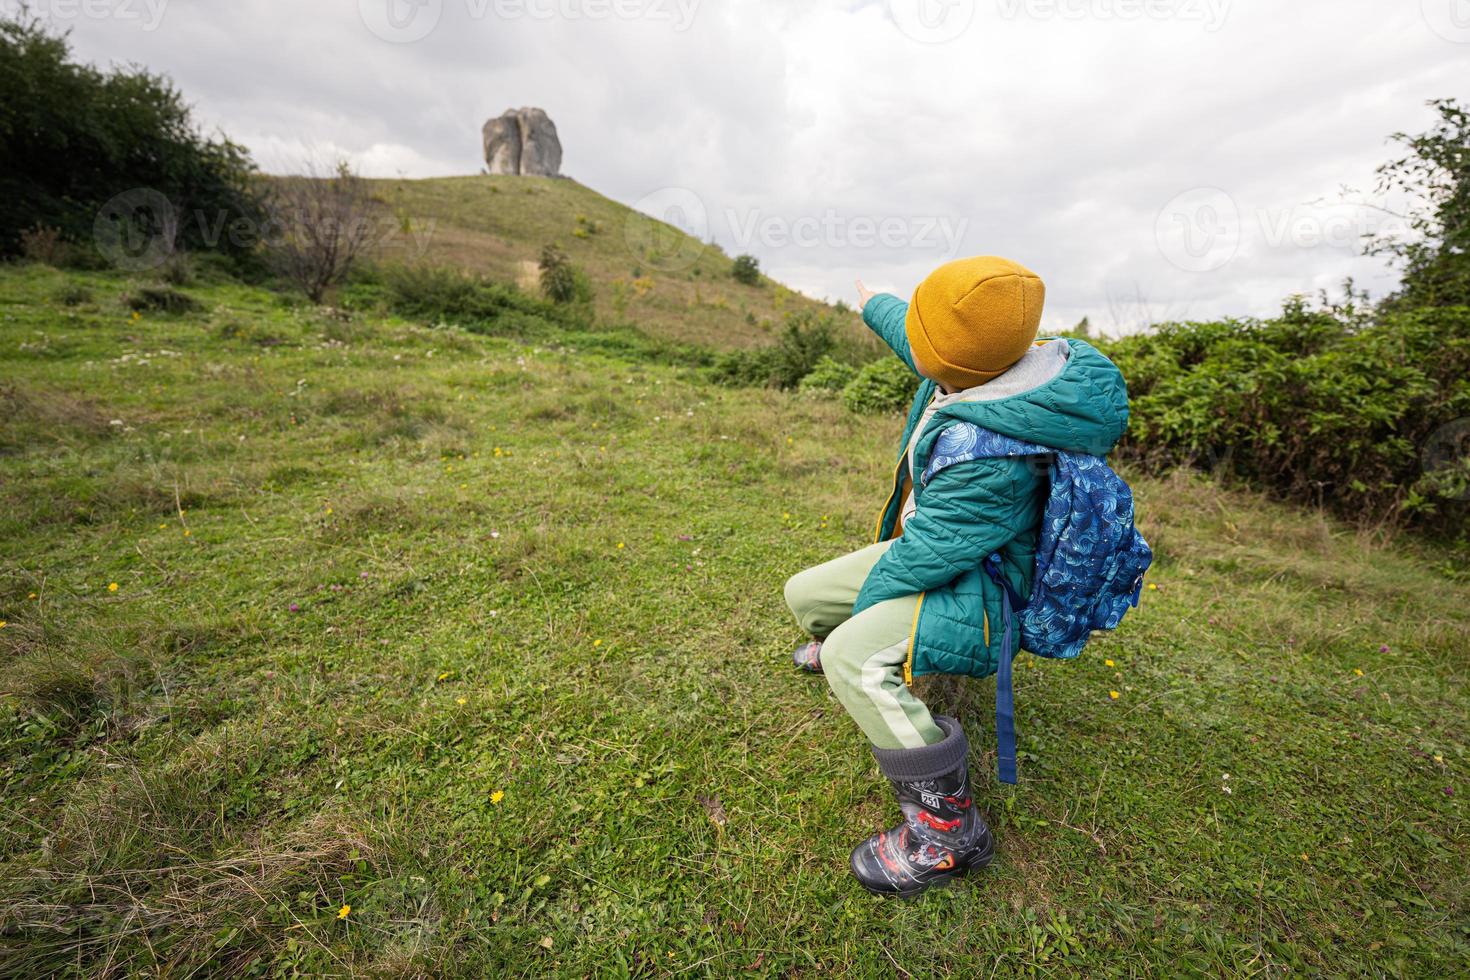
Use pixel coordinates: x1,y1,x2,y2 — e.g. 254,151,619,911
1367,98,1470,310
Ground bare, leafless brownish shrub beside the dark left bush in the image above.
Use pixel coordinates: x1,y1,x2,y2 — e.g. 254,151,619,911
266,160,373,303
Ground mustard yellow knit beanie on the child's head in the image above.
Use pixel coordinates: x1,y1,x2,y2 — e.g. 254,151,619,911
904,256,1047,391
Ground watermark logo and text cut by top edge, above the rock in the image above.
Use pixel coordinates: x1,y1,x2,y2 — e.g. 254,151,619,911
357,0,700,44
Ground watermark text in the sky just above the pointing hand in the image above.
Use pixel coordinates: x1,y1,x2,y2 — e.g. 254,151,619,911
725,207,970,259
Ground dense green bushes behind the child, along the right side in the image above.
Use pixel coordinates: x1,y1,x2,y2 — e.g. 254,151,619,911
1103,300,1470,532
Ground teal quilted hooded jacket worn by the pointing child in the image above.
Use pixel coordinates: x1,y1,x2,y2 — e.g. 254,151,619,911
853,294,1127,680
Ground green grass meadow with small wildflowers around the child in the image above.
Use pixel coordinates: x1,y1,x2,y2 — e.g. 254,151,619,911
0,266,1470,977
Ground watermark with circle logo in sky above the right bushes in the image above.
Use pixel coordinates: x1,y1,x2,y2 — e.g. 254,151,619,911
1154,187,1408,272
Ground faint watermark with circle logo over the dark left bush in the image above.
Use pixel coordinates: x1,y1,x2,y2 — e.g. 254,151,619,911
93,187,437,272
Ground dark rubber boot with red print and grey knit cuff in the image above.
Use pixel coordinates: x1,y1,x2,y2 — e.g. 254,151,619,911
850,716,995,898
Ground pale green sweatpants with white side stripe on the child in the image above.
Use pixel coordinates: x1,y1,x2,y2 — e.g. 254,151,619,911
786,541,945,749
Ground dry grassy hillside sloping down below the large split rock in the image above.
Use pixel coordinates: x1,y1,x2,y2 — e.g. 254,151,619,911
361,175,864,348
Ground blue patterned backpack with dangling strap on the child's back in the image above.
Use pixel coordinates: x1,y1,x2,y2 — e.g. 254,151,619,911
923,422,1154,783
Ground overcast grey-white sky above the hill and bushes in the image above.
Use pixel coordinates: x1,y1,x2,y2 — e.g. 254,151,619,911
22,0,1470,329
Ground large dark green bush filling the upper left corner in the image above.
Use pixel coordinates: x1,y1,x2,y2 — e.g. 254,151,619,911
0,16,260,257
